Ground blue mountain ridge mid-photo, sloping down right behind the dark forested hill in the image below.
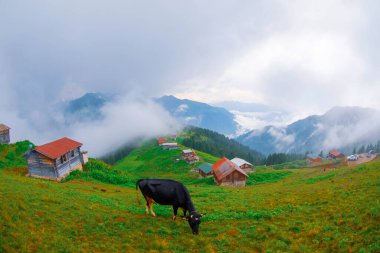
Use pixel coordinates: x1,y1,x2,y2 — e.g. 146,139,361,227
155,96,239,135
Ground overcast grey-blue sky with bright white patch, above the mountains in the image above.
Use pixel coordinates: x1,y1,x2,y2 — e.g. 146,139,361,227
0,0,380,150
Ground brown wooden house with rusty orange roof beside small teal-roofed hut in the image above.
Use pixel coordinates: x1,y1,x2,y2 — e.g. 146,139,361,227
212,157,248,187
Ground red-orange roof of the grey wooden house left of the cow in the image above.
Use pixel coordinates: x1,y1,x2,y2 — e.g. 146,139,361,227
34,137,83,159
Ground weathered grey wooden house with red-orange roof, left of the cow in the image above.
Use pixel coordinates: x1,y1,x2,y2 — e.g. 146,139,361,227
26,137,84,180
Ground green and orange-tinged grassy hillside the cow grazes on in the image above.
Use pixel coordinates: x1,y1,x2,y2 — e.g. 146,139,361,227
0,143,380,252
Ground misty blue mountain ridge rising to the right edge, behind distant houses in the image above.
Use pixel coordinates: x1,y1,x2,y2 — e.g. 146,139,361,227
236,107,380,154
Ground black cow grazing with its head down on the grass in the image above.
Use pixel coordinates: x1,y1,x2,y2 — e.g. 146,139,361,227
136,179,202,235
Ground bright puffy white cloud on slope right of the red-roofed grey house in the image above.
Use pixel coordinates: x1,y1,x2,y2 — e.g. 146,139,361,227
71,97,181,156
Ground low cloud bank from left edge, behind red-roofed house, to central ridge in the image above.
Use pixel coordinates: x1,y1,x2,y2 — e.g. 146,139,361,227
1,95,181,157
